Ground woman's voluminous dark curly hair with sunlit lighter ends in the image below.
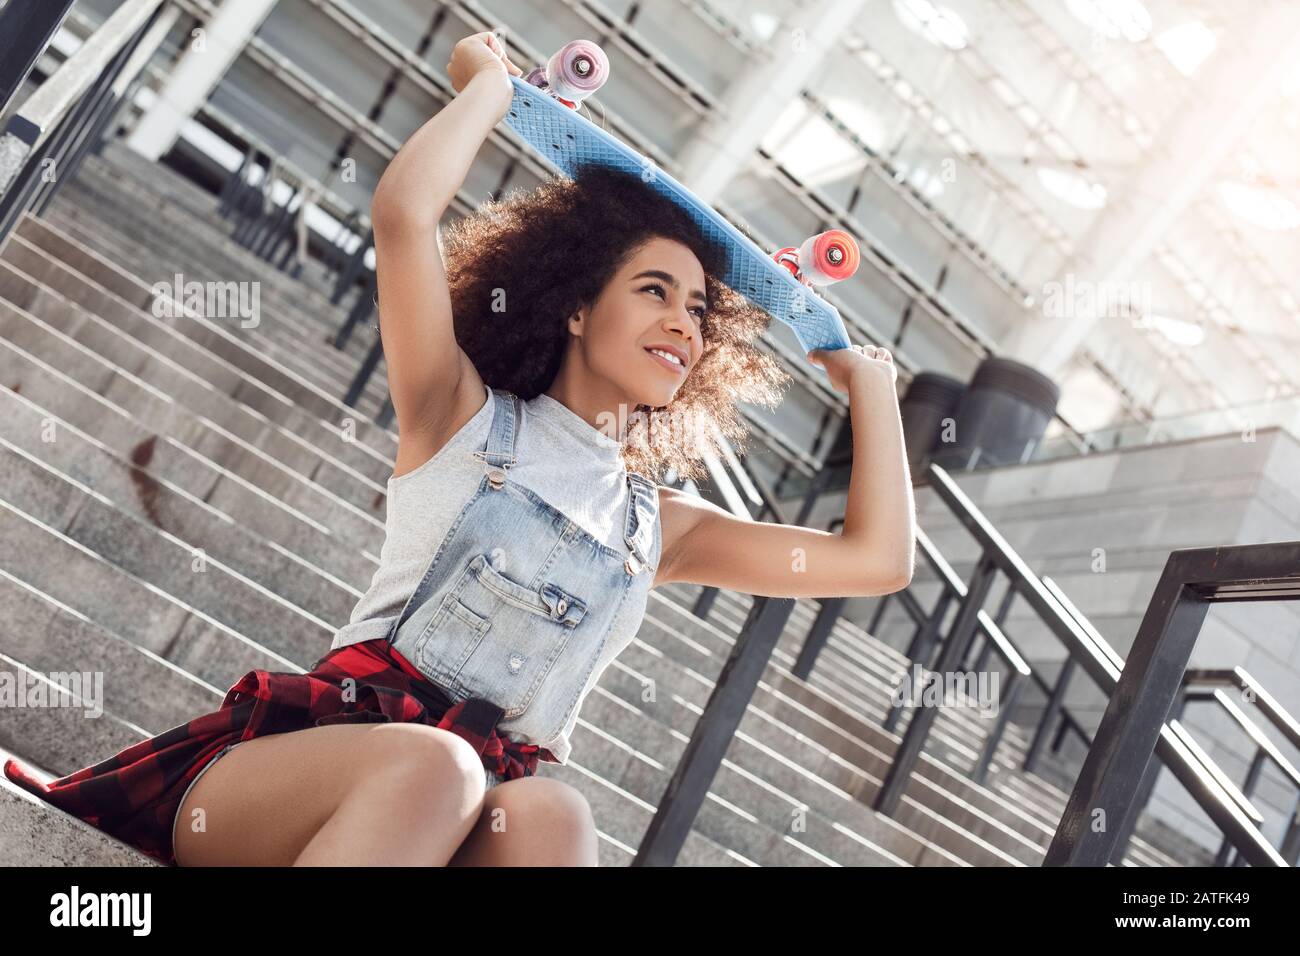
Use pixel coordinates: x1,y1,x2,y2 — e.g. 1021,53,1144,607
442,165,789,481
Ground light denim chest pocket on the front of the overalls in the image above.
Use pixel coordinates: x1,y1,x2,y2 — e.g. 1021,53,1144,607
416,554,588,718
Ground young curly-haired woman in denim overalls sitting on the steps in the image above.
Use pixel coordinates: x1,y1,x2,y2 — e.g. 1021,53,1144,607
5,34,914,866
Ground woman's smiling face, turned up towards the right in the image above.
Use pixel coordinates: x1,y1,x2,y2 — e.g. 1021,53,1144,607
569,237,707,407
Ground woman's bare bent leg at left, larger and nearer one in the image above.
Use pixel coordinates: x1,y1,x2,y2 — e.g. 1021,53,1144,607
176,723,485,866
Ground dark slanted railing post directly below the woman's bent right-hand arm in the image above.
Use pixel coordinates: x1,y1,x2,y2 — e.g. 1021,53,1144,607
632,597,794,866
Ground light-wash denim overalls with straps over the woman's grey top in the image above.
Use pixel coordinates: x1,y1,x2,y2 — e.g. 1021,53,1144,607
387,389,660,747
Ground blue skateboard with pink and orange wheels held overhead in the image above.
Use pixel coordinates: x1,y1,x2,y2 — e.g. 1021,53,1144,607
504,40,859,352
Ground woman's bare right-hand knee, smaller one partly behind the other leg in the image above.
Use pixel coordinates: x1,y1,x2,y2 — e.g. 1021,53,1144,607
447,777,598,866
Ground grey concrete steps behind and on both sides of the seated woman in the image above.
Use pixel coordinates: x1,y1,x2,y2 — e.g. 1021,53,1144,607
0,144,1208,866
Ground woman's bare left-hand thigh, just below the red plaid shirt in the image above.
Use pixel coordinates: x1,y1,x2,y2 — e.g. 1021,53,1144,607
176,723,469,866
